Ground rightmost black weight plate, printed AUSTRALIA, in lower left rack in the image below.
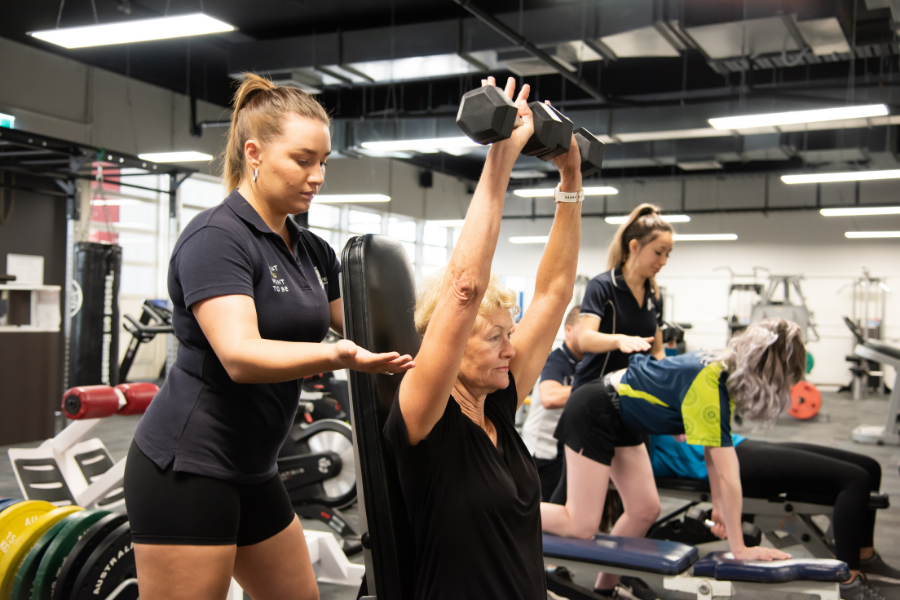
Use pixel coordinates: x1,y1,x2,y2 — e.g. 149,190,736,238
68,523,138,600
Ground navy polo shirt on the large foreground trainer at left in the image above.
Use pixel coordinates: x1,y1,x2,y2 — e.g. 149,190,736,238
134,190,340,483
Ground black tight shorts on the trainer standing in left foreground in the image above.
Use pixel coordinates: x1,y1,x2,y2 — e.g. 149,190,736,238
125,442,294,546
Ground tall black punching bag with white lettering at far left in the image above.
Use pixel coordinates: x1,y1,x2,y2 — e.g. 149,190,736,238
69,242,122,386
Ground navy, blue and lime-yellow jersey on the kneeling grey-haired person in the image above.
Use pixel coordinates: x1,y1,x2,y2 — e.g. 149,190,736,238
619,352,734,447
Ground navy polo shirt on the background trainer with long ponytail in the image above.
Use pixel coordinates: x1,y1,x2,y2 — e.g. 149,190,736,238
572,265,663,391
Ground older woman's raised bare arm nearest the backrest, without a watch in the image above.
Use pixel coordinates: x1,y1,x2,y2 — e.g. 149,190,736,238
400,78,532,445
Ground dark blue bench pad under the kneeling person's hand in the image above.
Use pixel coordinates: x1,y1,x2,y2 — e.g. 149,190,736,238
694,552,850,583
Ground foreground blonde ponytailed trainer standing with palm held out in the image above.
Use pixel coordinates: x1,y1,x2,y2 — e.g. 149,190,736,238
125,73,413,600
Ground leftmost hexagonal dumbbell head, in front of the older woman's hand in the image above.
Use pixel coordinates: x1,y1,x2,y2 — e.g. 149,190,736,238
456,85,519,145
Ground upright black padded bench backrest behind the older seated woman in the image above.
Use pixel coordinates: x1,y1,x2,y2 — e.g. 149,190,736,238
341,234,420,600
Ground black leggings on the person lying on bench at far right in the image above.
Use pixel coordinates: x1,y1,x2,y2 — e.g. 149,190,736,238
736,440,881,569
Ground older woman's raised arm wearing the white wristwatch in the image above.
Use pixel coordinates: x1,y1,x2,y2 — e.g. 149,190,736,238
509,136,581,406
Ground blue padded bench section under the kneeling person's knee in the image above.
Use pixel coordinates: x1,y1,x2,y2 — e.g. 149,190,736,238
543,533,700,575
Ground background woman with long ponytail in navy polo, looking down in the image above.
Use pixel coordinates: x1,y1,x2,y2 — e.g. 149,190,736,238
572,204,674,391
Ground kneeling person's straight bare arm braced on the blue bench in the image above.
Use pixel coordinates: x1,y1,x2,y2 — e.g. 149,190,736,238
703,446,791,560
